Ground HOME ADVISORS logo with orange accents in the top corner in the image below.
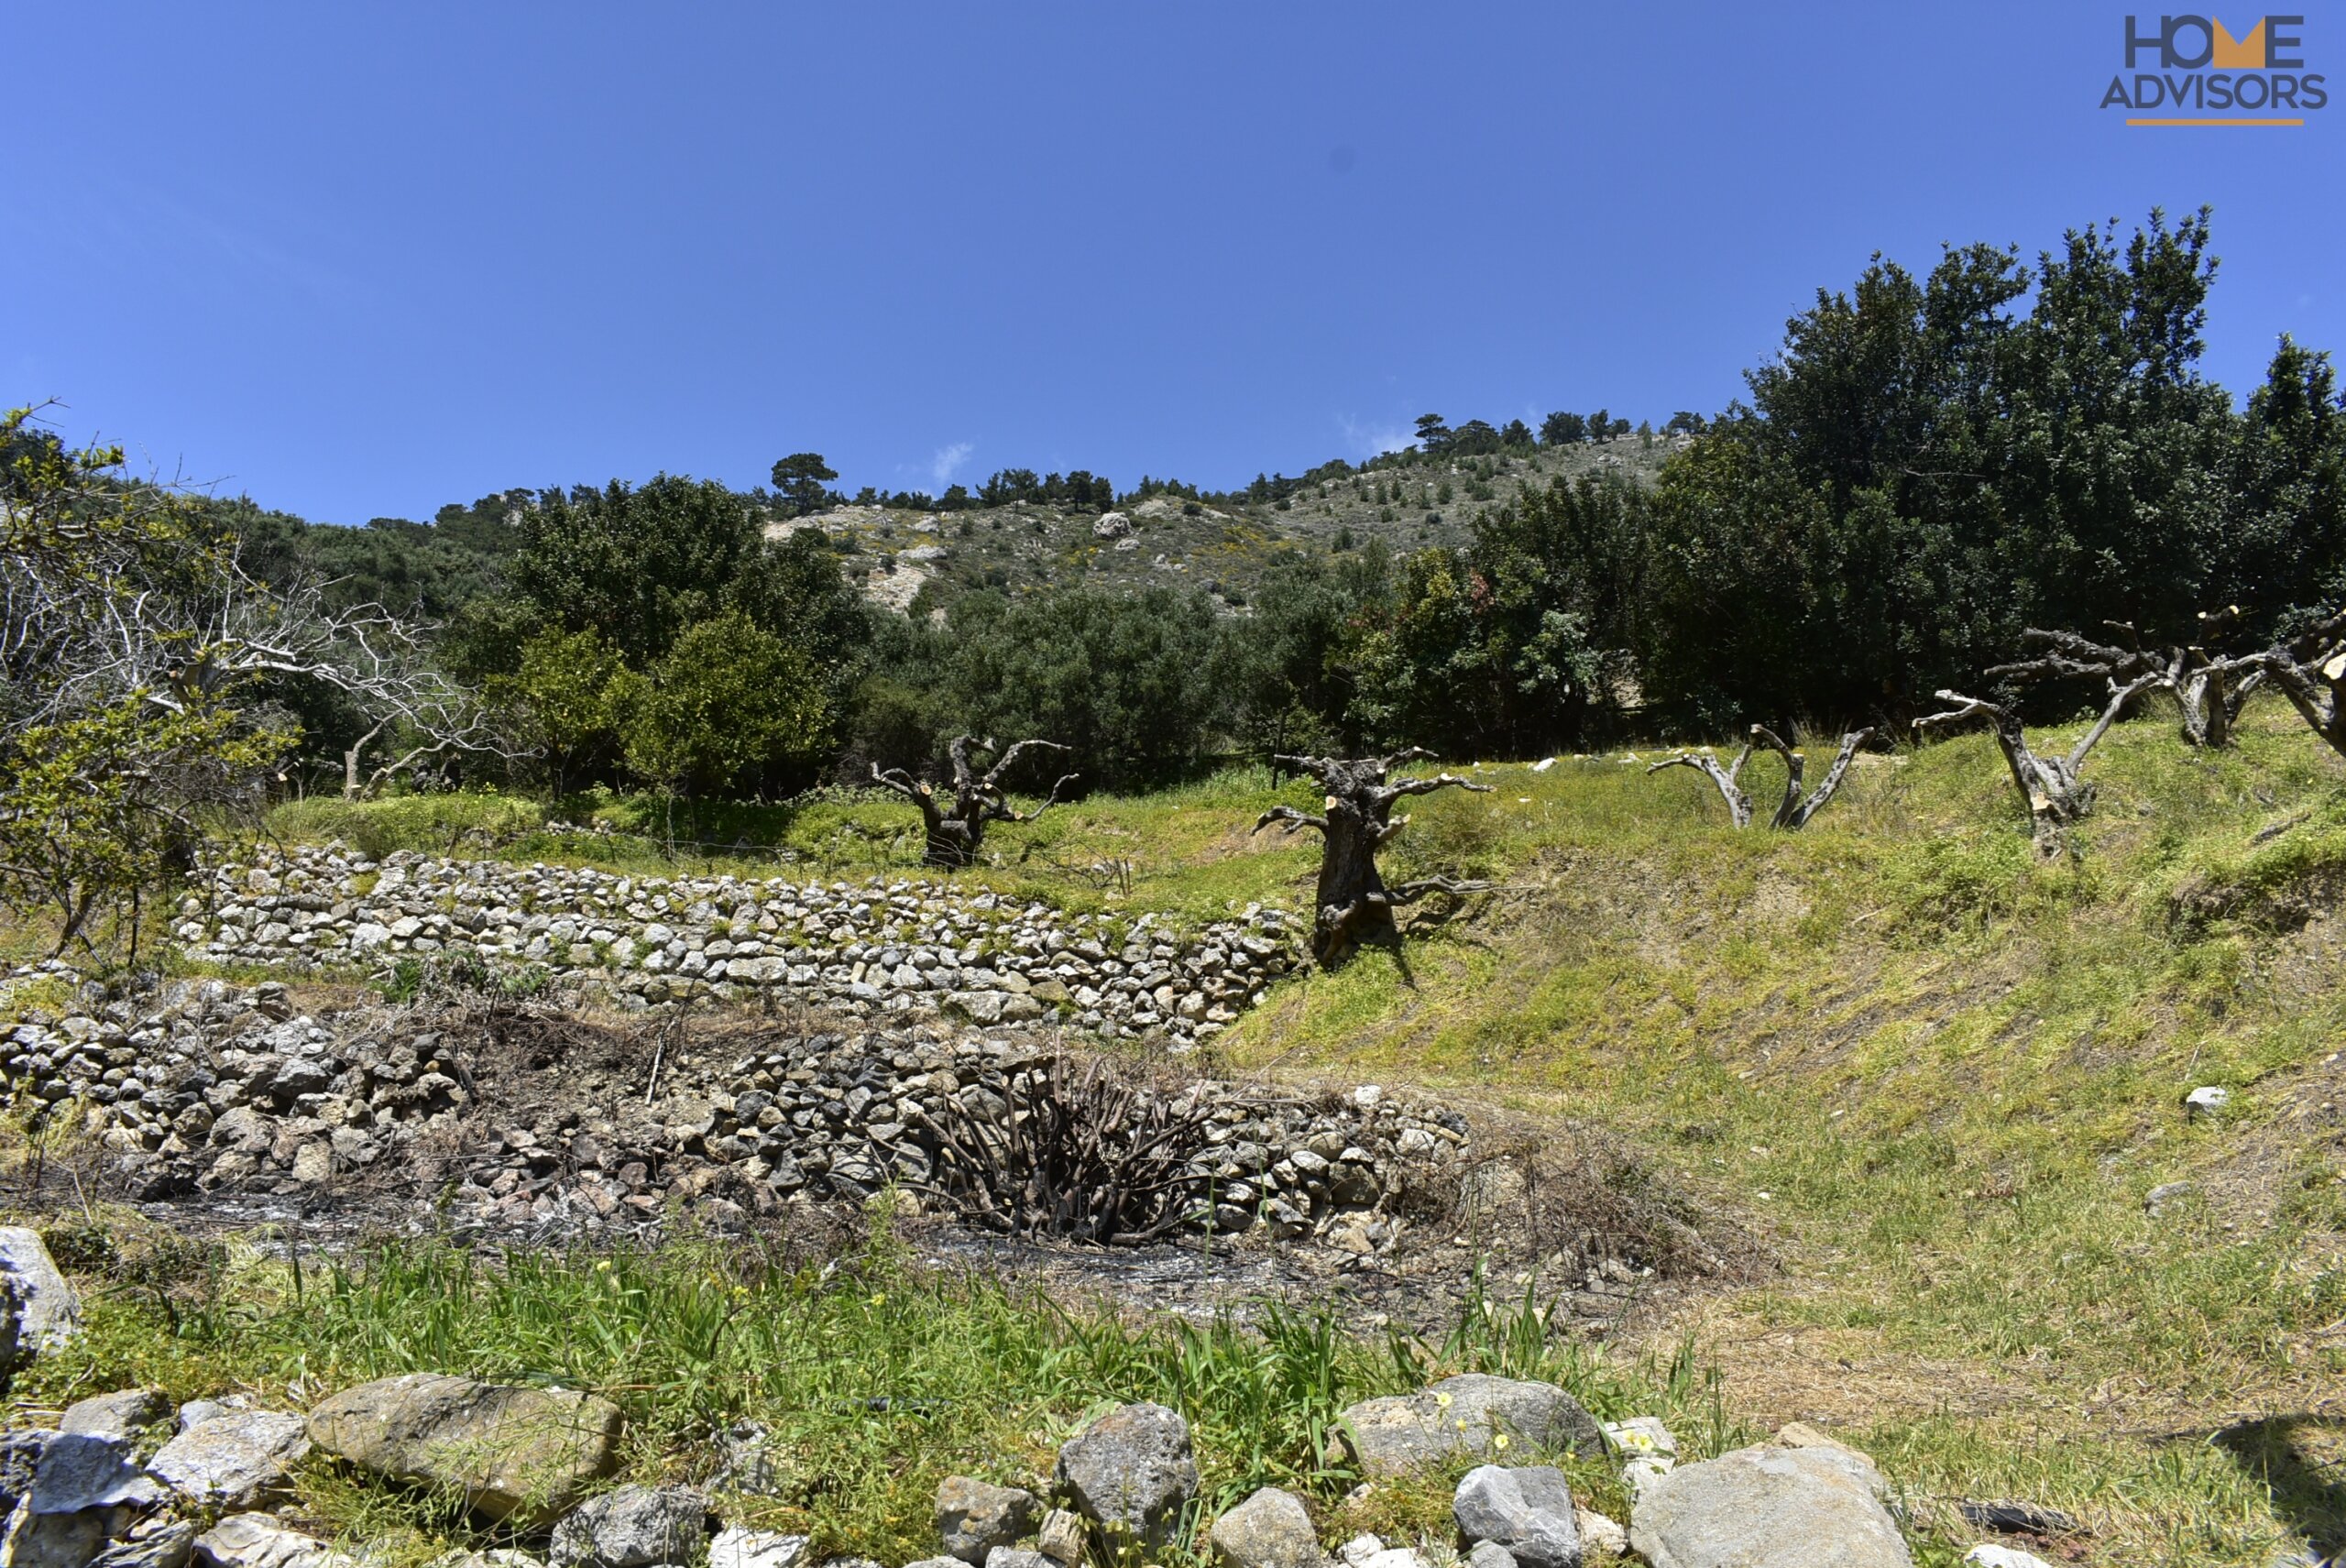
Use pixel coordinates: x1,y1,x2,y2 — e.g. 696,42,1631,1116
2102,16,2330,125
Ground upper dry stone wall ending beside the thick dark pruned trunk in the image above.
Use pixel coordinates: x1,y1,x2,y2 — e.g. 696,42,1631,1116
176,845,1299,1047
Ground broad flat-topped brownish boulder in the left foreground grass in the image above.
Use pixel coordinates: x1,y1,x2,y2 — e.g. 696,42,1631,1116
310,1373,619,1526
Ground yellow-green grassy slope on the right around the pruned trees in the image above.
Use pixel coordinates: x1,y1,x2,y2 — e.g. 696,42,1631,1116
160,704,2346,1568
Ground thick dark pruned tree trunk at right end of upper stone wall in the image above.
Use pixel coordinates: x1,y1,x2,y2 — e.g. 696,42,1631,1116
1255,747,1490,965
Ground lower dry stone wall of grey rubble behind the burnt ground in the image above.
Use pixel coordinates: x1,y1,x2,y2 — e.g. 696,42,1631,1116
0,974,1469,1255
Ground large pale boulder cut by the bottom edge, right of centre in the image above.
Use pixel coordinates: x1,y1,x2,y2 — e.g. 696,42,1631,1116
1628,1443,1914,1568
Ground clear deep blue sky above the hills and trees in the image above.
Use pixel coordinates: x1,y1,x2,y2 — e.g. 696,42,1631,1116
0,0,2346,523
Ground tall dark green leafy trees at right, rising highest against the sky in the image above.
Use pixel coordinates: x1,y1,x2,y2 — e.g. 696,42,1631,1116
1642,216,2346,720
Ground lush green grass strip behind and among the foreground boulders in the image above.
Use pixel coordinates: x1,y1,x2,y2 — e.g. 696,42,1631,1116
16,1228,1746,1561
